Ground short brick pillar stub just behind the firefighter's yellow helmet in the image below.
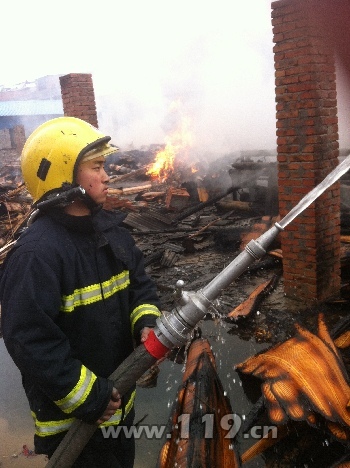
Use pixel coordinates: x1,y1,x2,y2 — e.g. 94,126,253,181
60,73,98,127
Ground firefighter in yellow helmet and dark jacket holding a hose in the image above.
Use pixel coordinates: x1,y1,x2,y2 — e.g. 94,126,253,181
0,117,160,468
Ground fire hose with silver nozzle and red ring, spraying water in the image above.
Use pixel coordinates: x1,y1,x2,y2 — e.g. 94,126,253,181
46,155,350,468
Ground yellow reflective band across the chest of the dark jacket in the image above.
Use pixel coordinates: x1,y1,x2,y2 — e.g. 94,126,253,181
60,270,130,312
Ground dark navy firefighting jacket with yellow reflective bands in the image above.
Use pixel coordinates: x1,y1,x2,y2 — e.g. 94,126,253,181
0,210,160,453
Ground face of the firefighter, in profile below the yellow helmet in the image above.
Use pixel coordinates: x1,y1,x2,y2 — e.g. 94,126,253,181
76,157,109,204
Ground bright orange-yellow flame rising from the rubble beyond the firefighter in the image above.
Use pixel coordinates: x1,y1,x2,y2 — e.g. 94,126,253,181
146,101,193,181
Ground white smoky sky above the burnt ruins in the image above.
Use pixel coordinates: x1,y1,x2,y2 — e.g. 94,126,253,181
0,0,348,156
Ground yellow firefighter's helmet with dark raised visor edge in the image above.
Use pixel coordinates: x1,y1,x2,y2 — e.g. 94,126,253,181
21,117,118,203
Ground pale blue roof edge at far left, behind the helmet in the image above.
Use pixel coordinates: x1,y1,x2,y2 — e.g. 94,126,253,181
0,99,63,117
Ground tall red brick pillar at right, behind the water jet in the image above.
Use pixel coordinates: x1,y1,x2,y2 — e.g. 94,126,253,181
272,0,340,303
